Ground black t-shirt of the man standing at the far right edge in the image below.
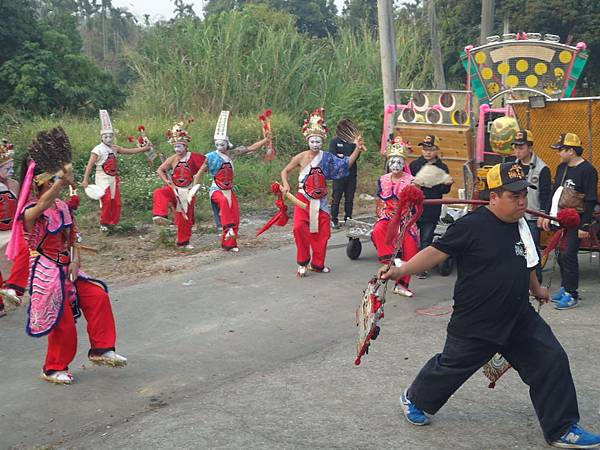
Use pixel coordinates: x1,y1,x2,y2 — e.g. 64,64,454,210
548,159,598,228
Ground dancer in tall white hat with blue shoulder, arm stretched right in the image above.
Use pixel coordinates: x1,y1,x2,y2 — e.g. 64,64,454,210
202,111,270,252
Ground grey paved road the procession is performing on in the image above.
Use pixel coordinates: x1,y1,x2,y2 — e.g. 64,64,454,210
0,234,600,450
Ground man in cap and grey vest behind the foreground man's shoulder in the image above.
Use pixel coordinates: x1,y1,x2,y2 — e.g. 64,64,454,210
512,130,552,283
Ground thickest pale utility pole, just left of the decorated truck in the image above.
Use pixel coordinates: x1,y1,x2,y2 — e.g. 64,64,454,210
377,0,396,106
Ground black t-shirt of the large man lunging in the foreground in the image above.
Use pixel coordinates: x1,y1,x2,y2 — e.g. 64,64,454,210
432,207,532,344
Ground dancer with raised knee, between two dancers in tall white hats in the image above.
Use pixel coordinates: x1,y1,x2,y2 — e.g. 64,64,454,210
152,122,206,250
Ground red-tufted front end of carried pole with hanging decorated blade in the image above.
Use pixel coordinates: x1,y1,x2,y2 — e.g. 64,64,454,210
354,185,424,366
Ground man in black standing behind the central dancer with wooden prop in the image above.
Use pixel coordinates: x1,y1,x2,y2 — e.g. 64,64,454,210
329,119,358,228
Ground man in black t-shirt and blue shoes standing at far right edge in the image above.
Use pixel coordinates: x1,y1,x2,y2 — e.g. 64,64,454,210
541,133,598,310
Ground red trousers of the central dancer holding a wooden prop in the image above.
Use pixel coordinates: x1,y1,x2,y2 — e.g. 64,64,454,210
294,192,331,270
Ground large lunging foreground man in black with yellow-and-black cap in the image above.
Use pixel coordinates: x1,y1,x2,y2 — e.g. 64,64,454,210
379,163,600,448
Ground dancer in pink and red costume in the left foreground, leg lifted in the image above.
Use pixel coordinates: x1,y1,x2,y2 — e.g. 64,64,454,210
7,128,127,384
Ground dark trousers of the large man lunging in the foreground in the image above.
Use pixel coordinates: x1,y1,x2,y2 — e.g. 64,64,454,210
408,308,579,442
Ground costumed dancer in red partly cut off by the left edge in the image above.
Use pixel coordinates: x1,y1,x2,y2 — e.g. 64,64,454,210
0,139,29,317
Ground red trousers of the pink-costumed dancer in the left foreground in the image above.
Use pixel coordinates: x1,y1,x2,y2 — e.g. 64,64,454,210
44,279,117,372
